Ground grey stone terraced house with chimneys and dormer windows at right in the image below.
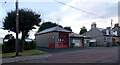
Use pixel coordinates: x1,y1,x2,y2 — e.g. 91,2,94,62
83,22,120,46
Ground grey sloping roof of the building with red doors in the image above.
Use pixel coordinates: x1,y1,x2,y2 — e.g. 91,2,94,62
36,26,71,34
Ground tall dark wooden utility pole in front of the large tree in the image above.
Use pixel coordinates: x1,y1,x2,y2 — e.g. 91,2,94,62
15,0,19,56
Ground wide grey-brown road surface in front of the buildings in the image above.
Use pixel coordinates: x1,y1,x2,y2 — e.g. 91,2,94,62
18,47,118,63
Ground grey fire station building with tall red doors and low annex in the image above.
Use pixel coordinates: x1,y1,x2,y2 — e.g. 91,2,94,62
35,26,90,48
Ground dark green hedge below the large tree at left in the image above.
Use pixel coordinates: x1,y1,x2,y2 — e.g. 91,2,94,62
2,39,36,53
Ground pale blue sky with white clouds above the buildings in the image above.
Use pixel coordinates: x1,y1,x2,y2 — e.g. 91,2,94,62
0,0,119,39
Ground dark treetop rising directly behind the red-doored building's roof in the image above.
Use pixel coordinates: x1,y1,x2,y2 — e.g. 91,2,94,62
38,22,62,32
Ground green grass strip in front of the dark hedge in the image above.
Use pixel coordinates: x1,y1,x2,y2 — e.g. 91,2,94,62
2,50,46,58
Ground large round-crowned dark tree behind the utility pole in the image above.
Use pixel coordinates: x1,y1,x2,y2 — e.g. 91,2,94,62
3,9,41,51
